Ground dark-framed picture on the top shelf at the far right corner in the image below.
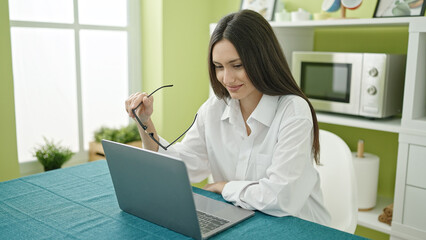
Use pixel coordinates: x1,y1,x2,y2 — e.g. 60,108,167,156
374,0,425,18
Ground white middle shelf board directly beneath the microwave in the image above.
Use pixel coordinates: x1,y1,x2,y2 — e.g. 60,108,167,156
317,112,401,133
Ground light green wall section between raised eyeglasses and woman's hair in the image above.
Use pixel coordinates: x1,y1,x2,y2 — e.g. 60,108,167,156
162,0,210,141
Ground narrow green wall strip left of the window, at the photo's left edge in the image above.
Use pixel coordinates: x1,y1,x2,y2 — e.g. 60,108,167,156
0,1,19,181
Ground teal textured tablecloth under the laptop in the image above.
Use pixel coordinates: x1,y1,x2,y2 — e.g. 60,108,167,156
0,160,361,240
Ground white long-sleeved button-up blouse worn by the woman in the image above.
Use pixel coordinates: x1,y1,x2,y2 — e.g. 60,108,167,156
159,94,330,225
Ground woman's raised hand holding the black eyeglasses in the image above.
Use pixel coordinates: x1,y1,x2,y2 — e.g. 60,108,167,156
125,92,154,123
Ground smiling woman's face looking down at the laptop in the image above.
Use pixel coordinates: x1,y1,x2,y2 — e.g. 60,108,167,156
212,39,262,101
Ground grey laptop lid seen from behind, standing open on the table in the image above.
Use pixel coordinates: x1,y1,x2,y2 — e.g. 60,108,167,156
102,140,201,239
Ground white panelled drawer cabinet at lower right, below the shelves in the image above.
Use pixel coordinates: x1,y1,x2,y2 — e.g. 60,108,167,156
392,135,426,239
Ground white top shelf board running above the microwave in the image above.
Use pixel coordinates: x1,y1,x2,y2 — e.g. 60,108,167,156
270,17,426,28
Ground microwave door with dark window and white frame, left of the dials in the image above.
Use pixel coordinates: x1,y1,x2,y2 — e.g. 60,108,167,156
299,53,362,115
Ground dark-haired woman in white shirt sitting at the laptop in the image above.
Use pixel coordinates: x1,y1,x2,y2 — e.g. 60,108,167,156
126,10,330,225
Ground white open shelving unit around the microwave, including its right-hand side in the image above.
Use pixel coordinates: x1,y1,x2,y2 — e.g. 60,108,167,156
271,17,426,239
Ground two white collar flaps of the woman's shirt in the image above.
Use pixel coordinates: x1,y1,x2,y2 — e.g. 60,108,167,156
221,94,279,127
